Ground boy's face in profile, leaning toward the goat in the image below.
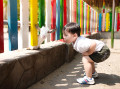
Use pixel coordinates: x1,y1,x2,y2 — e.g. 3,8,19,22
63,30,77,43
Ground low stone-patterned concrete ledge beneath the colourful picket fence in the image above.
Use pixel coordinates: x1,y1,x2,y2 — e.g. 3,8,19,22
0,33,98,89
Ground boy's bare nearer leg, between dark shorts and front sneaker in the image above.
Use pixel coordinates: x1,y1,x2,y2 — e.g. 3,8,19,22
82,56,95,78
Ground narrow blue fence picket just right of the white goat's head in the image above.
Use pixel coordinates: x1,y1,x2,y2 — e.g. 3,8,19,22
56,0,60,40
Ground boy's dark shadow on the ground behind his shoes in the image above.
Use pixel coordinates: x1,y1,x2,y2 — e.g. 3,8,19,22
95,73,120,86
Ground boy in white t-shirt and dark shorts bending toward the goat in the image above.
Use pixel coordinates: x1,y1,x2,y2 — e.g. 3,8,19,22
63,22,110,84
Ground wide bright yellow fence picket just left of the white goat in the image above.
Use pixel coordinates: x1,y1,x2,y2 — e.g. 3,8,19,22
30,0,38,47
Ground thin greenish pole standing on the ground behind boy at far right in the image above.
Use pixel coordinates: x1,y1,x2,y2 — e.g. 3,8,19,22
111,0,115,48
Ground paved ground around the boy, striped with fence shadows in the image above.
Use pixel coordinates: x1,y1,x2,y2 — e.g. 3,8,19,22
28,39,120,89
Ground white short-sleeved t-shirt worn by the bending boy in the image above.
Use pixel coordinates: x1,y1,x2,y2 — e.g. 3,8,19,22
73,36,105,53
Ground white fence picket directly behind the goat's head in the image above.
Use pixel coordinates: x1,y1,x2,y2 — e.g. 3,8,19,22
45,0,51,43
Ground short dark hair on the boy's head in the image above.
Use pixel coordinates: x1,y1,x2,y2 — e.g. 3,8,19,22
63,22,81,36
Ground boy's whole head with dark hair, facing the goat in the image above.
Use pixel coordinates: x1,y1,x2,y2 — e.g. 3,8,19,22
63,22,81,43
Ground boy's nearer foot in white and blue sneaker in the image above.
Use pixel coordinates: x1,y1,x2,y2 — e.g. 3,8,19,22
77,76,95,85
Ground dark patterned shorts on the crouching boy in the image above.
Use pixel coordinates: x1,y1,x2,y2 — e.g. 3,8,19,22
89,45,110,63
